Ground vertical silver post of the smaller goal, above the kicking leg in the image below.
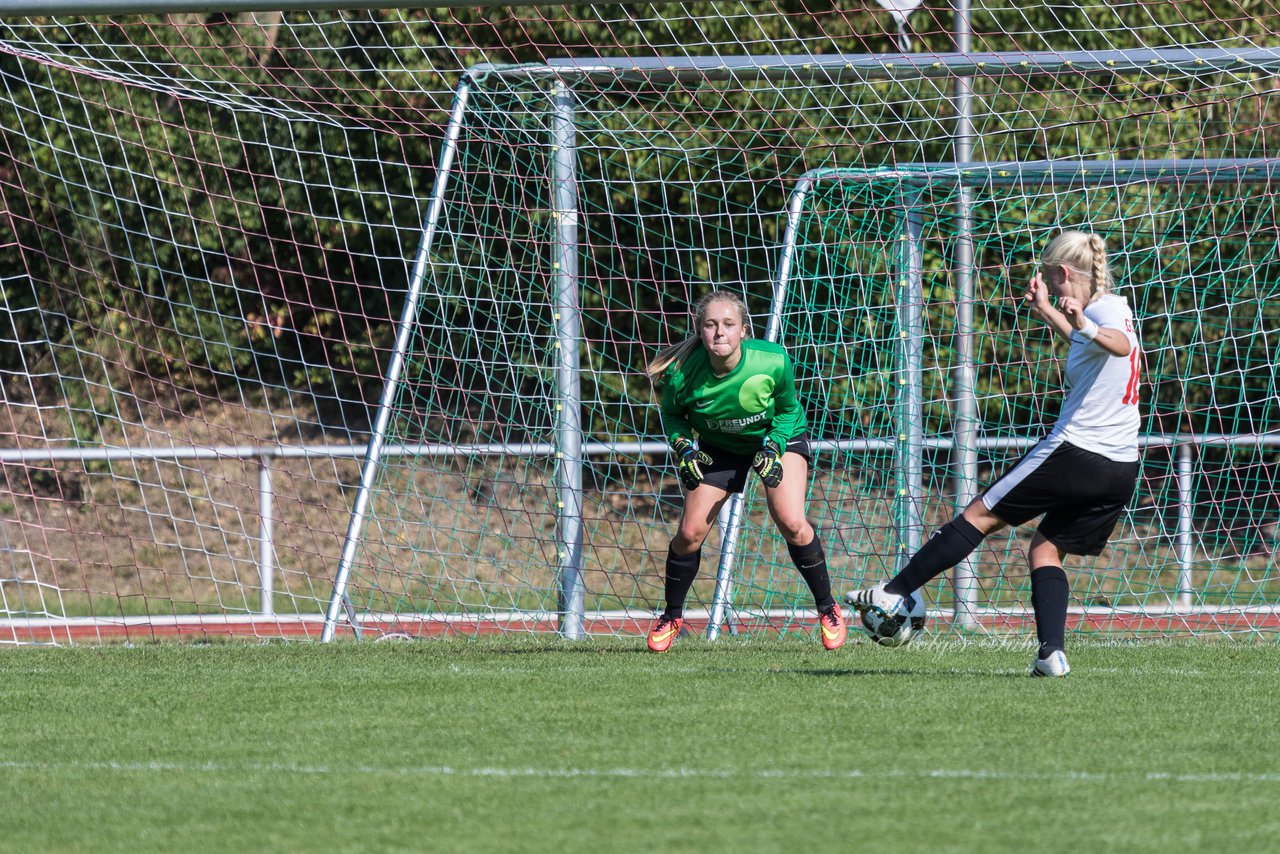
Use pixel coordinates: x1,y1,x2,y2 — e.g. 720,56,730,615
893,189,924,570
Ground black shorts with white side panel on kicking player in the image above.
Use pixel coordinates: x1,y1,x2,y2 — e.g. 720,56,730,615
982,439,1138,554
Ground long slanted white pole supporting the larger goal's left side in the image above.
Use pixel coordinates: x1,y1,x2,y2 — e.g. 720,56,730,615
320,78,471,643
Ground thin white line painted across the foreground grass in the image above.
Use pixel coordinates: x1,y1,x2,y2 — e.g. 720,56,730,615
0,761,1280,784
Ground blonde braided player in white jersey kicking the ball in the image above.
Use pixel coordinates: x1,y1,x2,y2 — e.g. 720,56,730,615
845,232,1142,676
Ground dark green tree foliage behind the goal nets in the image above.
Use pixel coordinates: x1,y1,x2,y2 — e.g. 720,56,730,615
0,6,1280,439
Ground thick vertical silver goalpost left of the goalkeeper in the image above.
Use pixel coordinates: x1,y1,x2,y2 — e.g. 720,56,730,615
552,82,585,640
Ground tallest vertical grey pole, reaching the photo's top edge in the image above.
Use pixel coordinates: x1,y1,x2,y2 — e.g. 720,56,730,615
951,0,978,629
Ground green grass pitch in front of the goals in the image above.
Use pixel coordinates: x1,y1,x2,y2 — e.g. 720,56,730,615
0,638,1280,851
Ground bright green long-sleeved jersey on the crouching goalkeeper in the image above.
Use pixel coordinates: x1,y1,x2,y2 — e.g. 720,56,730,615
662,338,805,453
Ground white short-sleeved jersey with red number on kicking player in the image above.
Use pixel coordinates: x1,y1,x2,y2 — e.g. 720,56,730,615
1048,293,1142,462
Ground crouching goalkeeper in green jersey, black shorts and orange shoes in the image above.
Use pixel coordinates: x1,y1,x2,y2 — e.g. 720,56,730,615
648,291,847,653
